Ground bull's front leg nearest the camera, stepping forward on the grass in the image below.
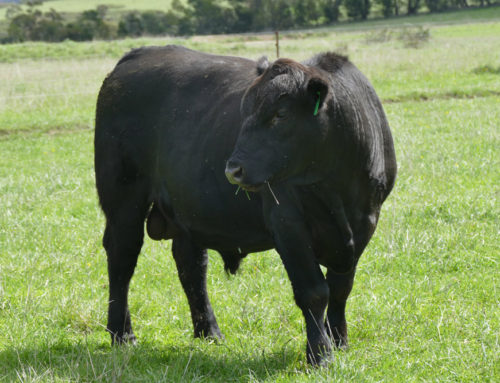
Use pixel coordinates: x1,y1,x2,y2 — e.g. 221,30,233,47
263,190,331,366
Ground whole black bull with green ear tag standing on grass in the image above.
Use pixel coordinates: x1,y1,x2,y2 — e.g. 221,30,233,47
95,46,396,364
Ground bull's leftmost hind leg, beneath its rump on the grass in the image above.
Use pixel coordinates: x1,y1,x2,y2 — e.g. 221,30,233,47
103,188,148,344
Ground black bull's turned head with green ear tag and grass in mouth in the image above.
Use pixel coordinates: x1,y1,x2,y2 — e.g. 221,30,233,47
226,59,331,191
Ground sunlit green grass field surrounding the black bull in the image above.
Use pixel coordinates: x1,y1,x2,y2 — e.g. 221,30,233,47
0,8,500,382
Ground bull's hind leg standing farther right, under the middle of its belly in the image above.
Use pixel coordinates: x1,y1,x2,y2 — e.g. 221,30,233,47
172,235,222,338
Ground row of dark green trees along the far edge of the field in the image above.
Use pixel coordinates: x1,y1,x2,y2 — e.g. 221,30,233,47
3,0,499,42
